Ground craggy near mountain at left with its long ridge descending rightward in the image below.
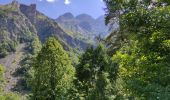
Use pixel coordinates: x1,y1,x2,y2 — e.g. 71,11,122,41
0,1,89,57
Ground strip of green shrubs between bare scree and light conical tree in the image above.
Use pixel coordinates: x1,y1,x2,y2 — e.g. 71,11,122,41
14,37,42,92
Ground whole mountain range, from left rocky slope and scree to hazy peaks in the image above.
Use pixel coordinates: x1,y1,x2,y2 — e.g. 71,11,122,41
0,1,107,95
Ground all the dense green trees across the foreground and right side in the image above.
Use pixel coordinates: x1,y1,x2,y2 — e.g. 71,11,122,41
0,0,170,100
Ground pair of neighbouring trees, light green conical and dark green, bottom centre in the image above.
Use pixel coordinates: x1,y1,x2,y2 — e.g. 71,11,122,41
29,37,117,100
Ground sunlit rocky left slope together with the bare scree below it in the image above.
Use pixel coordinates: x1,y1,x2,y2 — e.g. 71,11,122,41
0,2,37,92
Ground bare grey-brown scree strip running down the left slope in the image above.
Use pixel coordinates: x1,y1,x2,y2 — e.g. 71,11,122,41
0,44,25,92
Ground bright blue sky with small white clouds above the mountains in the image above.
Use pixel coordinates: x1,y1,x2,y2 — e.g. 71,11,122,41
0,0,105,19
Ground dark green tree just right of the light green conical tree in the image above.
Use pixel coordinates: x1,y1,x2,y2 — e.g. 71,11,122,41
76,45,115,100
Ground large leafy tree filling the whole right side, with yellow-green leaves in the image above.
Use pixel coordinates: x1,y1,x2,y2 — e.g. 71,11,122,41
105,0,170,100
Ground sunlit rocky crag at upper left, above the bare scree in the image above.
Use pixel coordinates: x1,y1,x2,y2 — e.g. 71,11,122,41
0,2,37,58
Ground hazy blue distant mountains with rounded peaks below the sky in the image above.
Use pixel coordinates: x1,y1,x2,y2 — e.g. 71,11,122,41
56,12,108,40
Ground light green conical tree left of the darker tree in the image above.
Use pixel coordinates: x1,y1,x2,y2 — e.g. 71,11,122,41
32,37,75,100
